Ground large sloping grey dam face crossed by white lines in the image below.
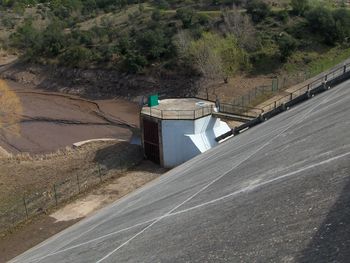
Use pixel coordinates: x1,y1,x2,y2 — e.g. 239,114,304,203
9,82,350,262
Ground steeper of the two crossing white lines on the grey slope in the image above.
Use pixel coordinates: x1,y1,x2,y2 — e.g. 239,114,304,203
96,82,339,263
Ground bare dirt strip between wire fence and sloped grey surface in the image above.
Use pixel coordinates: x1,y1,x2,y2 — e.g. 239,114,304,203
0,161,167,263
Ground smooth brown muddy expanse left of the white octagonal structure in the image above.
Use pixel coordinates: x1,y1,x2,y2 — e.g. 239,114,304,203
0,81,138,153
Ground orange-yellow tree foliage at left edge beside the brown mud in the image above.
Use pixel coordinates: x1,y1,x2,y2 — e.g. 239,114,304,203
0,80,22,135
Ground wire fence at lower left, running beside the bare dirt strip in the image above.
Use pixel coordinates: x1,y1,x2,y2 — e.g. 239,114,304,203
0,148,142,236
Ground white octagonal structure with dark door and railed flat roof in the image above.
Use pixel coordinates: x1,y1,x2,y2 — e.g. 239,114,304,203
141,98,230,167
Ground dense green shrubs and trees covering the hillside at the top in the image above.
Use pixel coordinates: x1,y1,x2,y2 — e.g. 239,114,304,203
0,0,350,81
